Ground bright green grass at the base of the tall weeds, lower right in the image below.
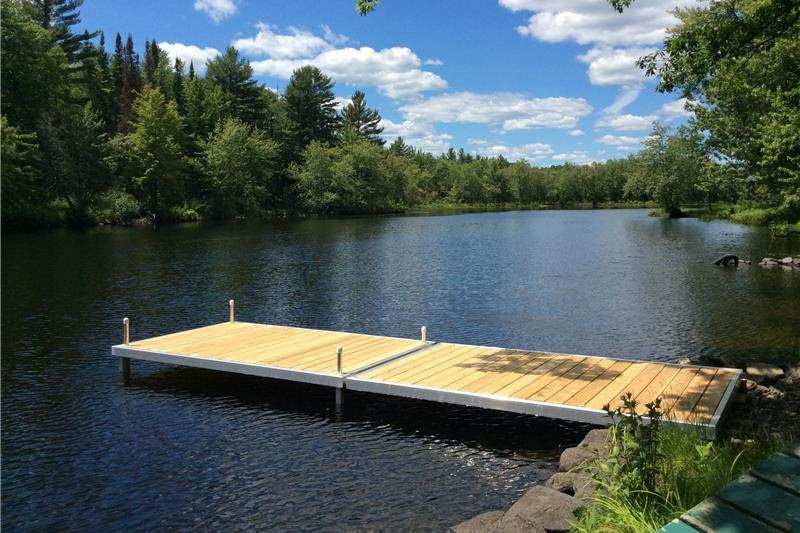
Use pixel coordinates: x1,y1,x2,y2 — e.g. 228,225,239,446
573,426,782,533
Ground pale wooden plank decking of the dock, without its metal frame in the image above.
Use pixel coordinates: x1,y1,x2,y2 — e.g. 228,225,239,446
129,322,736,424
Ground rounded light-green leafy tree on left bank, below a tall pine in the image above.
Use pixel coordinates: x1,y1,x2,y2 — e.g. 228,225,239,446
202,119,278,218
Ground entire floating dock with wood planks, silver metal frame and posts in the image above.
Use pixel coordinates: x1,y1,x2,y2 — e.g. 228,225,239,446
112,302,741,436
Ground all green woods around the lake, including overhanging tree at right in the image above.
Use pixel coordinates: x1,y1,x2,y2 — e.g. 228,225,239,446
0,0,800,227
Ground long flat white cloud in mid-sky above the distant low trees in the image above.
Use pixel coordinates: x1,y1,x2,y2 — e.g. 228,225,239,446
400,92,592,131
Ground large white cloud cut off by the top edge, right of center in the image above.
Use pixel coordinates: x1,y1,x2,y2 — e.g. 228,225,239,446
500,0,696,46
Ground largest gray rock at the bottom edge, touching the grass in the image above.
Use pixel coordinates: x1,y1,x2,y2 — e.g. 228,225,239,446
494,485,583,533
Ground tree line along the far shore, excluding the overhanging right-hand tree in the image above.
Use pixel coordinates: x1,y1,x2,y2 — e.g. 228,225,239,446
0,0,796,226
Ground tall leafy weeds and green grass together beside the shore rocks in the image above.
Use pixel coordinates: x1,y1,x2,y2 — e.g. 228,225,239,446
573,395,782,533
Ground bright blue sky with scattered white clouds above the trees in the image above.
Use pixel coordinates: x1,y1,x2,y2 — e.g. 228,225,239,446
82,0,694,165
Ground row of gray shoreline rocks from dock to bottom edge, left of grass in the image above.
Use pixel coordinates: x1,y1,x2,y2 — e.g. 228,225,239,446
451,429,609,533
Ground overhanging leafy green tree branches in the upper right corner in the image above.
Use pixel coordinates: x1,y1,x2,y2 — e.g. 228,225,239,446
640,0,800,212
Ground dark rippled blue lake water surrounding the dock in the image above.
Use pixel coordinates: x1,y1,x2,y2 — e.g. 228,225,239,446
2,210,800,531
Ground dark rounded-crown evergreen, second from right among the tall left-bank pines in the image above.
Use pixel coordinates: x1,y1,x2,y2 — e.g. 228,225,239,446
284,65,339,158
